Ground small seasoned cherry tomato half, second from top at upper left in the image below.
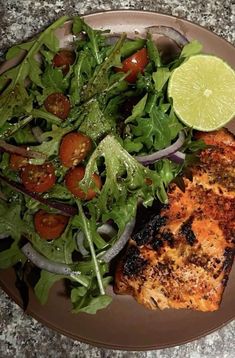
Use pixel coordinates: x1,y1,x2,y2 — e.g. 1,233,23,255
44,93,70,119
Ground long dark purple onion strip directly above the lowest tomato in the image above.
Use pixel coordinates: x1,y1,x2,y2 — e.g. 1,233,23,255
0,174,77,216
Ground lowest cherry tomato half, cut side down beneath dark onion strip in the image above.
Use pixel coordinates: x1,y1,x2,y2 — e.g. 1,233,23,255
34,210,69,240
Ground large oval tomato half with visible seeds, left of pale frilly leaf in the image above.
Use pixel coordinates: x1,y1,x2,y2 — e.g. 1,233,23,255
59,132,92,168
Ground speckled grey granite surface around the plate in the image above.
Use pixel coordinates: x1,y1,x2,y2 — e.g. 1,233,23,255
0,0,235,358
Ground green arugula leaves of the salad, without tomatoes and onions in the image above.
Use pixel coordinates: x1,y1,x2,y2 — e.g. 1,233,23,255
0,16,204,314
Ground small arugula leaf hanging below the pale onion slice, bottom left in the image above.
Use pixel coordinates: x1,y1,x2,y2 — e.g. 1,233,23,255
34,270,65,305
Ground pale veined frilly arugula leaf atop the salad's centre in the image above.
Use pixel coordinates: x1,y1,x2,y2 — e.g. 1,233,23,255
80,135,167,213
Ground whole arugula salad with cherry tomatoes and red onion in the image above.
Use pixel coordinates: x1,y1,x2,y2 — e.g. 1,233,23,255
0,17,211,314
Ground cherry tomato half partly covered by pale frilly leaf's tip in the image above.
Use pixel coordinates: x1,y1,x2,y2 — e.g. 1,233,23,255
65,167,102,200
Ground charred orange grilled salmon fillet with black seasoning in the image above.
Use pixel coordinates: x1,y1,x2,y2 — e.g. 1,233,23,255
114,130,235,311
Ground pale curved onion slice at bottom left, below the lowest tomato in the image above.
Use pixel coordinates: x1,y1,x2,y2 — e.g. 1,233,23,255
21,242,88,287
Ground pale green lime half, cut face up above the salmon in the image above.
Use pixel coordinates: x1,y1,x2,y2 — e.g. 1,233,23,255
168,55,235,131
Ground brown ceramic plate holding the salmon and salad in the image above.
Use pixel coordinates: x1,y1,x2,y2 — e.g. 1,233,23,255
0,10,235,350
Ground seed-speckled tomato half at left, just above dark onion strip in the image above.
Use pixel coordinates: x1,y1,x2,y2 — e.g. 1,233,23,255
21,163,56,193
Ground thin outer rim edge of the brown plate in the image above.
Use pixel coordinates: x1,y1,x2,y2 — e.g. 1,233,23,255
0,9,235,351
